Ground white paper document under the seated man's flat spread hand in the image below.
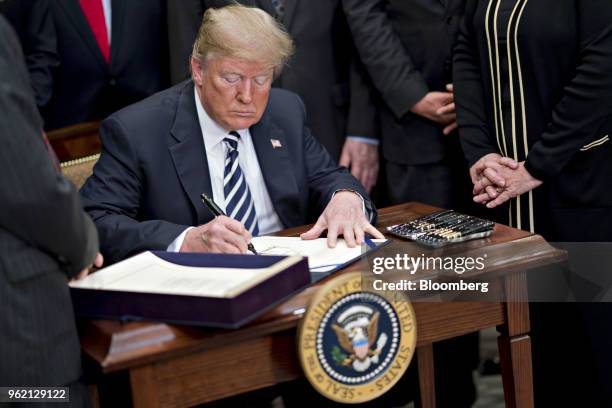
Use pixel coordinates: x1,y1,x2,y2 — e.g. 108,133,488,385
251,237,386,272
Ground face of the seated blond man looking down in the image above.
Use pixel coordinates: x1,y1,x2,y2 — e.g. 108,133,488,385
191,57,274,131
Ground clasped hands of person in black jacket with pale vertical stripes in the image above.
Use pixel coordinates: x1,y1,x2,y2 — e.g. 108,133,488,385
470,153,542,208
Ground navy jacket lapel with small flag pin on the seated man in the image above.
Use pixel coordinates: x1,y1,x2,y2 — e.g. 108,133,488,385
249,114,302,230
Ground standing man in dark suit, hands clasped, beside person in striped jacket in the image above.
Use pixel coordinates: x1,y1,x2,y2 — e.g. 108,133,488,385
343,0,478,407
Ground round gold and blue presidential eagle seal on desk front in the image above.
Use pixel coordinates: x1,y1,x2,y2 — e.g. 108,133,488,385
298,273,416,403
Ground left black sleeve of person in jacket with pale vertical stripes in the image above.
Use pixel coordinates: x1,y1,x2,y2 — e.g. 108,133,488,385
453,0,498,166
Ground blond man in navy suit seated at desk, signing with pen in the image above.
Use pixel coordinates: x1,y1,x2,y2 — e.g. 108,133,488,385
81,5,382,262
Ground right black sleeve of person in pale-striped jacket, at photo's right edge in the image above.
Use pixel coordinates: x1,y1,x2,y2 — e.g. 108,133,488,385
525,0,612,180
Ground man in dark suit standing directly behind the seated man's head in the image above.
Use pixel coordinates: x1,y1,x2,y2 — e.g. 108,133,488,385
168,0,379,191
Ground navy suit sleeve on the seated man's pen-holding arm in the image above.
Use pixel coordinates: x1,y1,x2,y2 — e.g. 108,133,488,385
81,116,188,263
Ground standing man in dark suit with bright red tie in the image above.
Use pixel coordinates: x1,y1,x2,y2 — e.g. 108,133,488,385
43,0,167,129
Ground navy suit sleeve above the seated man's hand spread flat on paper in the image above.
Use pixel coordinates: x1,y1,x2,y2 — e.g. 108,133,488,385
296,96,377,224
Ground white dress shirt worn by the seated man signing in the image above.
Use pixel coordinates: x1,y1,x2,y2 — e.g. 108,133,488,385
168,88,284,252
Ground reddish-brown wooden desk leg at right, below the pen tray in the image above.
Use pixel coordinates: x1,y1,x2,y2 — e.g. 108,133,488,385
498,272,534,408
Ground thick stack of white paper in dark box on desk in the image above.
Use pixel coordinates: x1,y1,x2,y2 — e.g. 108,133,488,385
70,252,301,297
